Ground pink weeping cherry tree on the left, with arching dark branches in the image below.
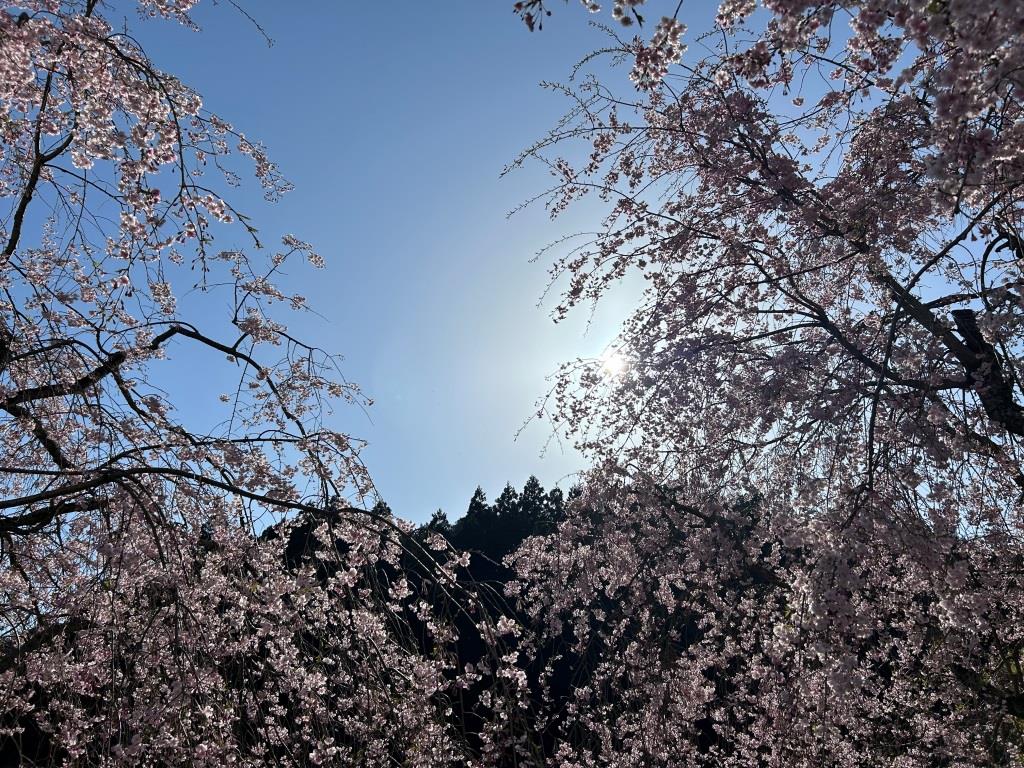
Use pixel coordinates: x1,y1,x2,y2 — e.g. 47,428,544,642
0,0,521,767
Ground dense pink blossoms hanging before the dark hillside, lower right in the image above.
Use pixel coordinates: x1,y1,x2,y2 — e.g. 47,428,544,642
509,476,1024,768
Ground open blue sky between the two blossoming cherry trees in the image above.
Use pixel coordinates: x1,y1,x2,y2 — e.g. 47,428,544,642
123,0,716,520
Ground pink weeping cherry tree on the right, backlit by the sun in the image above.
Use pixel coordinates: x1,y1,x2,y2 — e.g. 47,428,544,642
507,0,1024,766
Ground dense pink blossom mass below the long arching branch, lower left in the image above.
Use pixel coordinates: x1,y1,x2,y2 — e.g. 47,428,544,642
0,505,475,767
